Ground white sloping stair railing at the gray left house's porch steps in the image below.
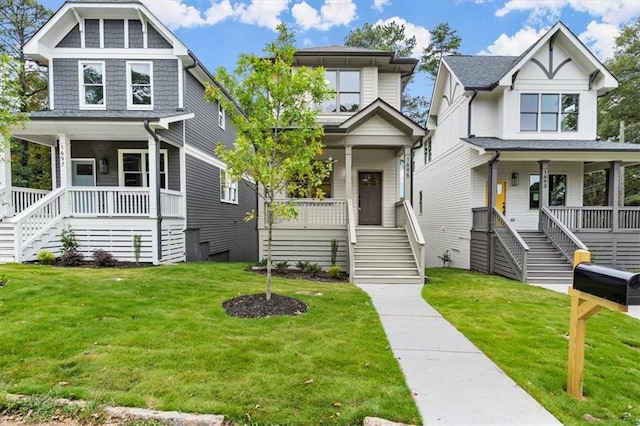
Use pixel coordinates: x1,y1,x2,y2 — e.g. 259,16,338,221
8,188,66,262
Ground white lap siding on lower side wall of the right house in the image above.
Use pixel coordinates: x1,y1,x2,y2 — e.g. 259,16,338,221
413,145,471,269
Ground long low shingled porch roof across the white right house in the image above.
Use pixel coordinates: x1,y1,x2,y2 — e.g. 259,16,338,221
462,137,640,153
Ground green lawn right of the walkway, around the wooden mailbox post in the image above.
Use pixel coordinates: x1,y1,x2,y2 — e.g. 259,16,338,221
423,268,640,425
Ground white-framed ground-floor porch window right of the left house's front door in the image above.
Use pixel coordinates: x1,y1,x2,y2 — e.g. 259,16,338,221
118,149,167,189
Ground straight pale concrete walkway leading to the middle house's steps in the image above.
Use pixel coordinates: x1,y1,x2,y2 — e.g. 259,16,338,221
358,284,561,425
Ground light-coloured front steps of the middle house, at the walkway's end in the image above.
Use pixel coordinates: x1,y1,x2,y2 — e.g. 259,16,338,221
353,227,424,284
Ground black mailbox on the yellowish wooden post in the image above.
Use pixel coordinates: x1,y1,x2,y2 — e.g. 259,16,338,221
573,263,640,305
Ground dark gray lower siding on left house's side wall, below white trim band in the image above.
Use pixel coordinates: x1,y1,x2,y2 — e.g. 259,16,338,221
187,155,258,261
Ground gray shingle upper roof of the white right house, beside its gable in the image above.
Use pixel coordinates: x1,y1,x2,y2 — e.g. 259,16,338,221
442,55,518,89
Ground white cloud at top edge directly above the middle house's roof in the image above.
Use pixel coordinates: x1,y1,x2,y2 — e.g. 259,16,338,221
291,0,356,31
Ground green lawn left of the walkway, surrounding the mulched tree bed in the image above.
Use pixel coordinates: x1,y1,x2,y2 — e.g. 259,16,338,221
0,263,419,425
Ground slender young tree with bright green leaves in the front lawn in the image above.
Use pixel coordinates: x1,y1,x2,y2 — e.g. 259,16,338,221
205,24,333,300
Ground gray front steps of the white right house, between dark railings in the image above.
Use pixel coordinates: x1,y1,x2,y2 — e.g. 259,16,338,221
518,231,573,285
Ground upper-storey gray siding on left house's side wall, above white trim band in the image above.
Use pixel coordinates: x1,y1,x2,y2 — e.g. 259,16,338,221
185,73,236,154
